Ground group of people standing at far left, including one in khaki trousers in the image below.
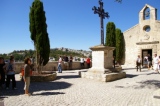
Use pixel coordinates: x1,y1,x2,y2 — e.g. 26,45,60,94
0,56,31,96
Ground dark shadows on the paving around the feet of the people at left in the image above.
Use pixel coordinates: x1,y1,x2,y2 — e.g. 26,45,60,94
0,81,72,97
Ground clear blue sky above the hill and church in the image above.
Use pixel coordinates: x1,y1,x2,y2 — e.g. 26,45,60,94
0,0,160,53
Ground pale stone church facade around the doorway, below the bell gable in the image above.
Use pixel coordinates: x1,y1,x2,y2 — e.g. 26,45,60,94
124,20,160,66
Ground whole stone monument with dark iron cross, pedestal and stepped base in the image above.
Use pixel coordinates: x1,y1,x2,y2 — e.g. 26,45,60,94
80,0,126,82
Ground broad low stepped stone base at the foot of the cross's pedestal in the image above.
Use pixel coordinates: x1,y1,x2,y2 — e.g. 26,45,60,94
80,68,126,82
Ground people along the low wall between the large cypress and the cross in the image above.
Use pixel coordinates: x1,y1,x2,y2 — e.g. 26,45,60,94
58,56,91,73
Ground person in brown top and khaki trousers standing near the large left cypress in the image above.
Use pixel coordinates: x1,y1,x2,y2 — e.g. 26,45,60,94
23,58,31,96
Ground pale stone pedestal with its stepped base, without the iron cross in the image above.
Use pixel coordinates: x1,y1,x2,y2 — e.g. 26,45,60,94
81,45,126,82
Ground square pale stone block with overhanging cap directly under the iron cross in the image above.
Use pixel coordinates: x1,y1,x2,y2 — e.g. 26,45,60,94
88,45,115,73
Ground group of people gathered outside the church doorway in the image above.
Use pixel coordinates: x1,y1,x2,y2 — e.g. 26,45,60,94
136,54,160,73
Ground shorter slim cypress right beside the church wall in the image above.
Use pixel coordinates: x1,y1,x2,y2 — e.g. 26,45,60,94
116,28,124,62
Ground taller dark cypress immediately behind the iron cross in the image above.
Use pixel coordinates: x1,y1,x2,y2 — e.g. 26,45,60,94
105,22,116,56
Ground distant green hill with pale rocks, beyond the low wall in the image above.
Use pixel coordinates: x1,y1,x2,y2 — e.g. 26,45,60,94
0,47,91,61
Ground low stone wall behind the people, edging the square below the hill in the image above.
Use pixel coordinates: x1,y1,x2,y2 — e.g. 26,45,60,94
15,62,92,73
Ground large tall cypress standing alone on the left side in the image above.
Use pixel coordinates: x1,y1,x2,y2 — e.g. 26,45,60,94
29,0,50,72
